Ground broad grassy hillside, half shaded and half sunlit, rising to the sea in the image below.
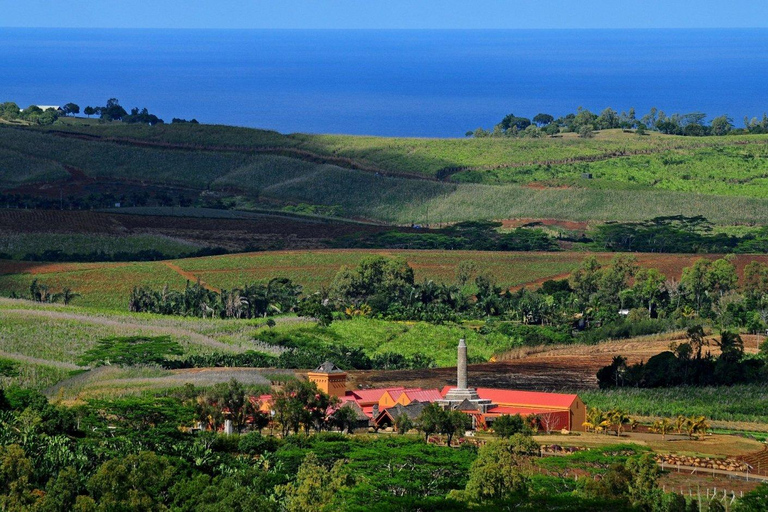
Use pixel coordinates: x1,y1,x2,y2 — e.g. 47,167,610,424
0,121,768,225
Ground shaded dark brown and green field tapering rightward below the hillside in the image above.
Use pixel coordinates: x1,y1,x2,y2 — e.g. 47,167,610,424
0,207,391,258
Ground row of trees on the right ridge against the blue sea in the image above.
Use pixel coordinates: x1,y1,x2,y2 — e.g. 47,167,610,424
466,107,768,138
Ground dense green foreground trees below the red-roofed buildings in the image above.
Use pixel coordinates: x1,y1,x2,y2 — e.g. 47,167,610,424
0,387,744,512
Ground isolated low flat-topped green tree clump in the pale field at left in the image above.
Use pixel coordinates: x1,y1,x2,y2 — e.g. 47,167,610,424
80,336,183,366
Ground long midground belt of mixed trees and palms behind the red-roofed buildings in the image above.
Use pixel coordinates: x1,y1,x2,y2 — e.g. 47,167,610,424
124,254,768,352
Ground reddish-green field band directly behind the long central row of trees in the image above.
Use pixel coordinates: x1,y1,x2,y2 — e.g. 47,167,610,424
6,249,768,311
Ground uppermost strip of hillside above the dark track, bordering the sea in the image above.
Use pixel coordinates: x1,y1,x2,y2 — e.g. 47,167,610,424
37,123,768,176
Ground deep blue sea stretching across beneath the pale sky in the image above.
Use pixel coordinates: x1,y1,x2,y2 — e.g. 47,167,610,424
0,29,768,137
